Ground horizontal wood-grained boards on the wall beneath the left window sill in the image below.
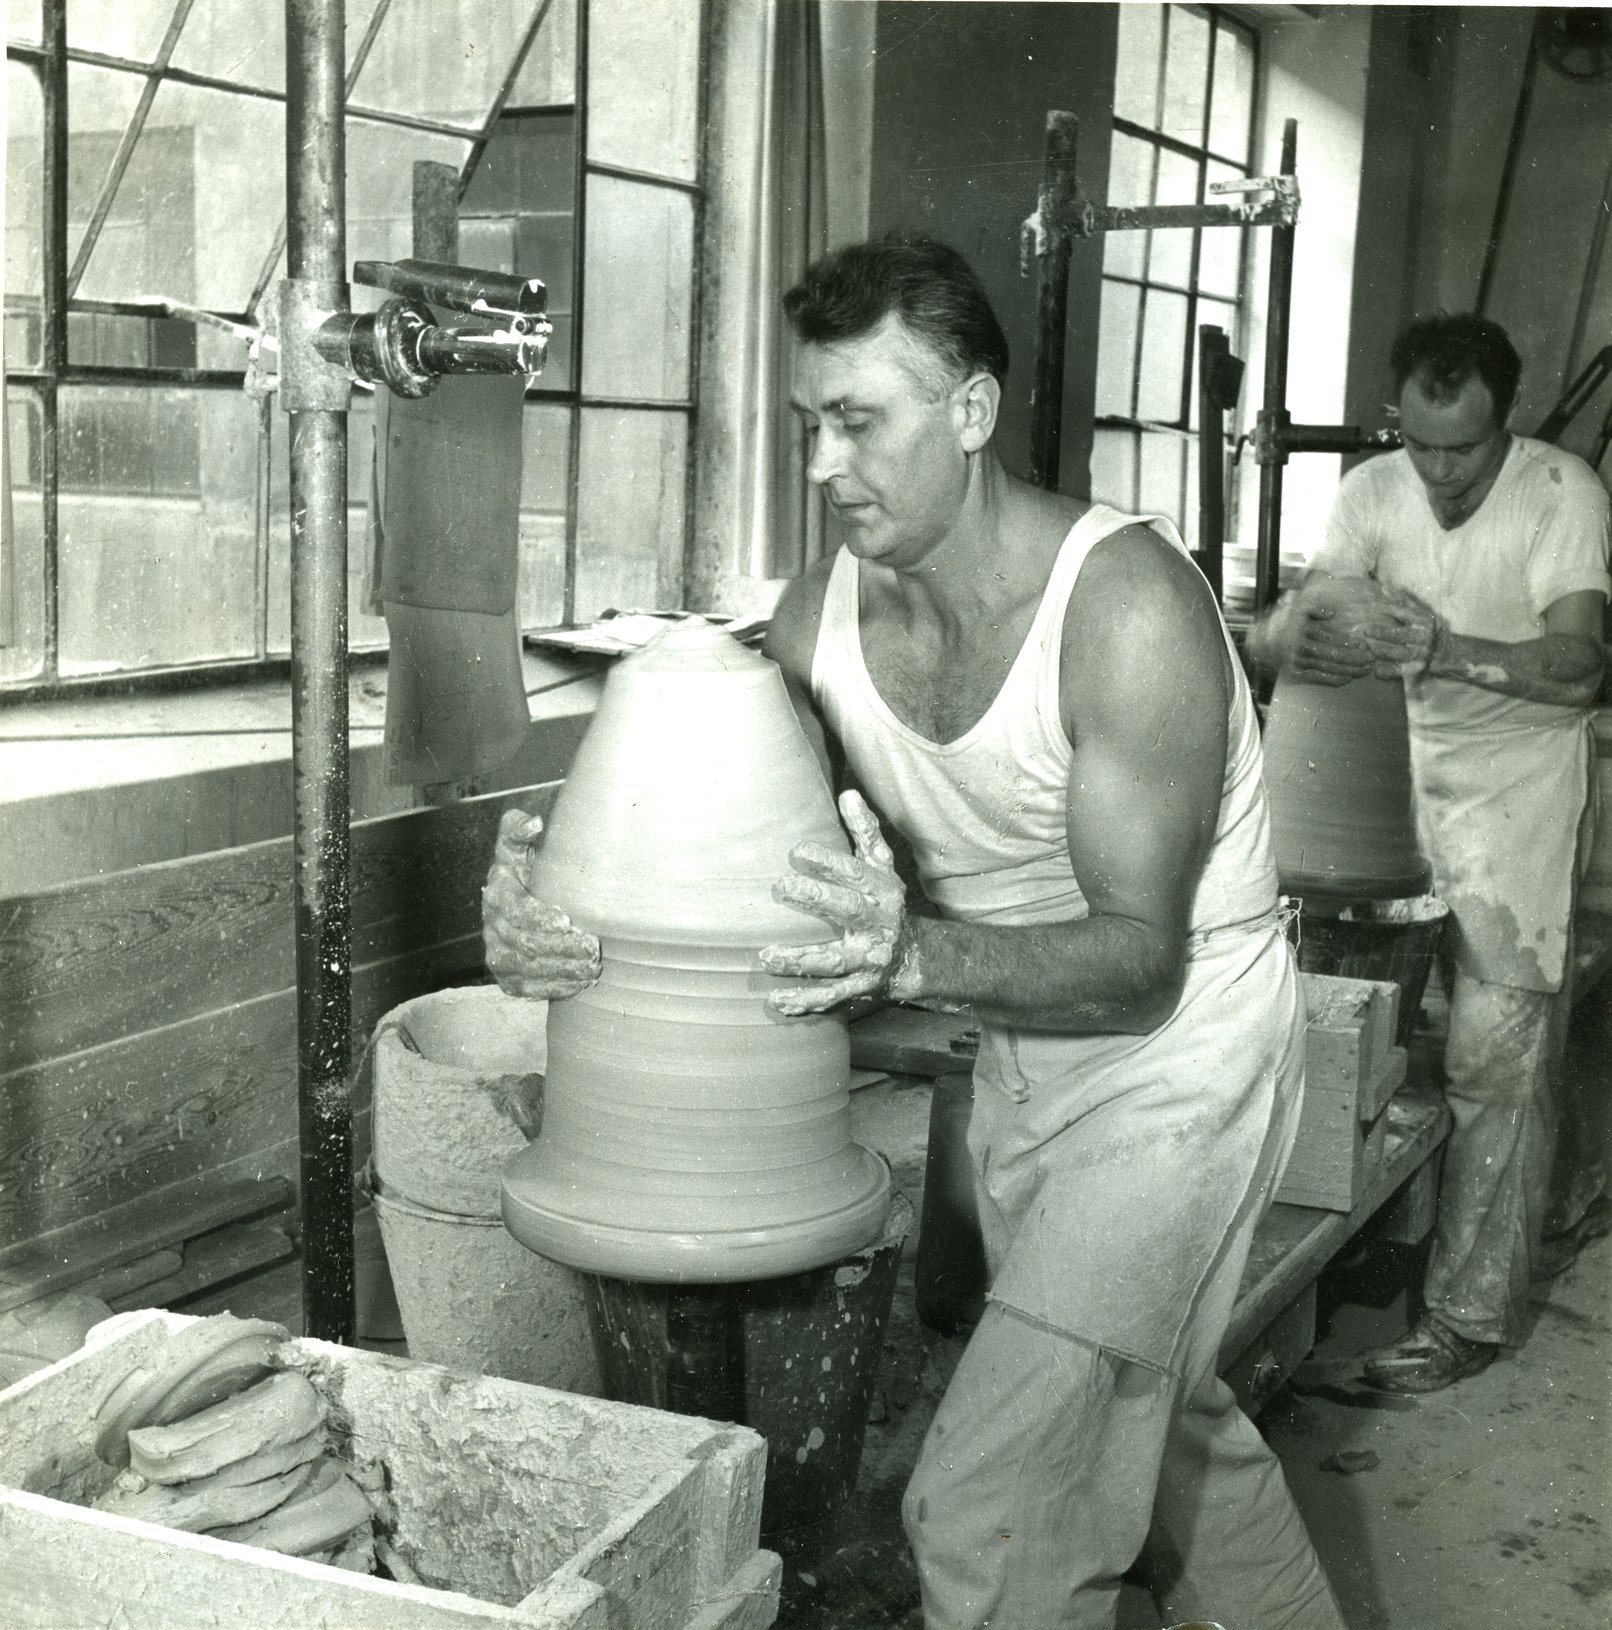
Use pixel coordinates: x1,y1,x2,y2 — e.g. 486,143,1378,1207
0,784,557,1250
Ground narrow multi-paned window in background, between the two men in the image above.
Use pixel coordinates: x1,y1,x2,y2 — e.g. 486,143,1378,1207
1092,5,1258,546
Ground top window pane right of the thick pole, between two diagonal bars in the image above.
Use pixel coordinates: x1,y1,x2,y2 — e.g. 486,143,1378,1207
352,0,547,129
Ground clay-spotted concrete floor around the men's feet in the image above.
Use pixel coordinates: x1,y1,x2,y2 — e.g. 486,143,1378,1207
186,996,1612,1630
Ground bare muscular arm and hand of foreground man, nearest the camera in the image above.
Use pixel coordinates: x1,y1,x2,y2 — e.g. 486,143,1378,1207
763,528,1231,1033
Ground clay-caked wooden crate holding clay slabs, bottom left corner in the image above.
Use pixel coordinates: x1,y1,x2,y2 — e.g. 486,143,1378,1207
0,1309,779,1630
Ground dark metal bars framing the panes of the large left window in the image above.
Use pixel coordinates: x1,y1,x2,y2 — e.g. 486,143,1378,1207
0,0,709,706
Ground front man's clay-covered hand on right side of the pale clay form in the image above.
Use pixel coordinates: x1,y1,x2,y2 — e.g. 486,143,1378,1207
761,792,914,1017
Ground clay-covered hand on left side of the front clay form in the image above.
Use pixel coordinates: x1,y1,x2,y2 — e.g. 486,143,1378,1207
481,810,600,1001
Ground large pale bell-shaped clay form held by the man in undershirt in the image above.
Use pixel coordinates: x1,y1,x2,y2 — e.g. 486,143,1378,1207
504,621,890,1284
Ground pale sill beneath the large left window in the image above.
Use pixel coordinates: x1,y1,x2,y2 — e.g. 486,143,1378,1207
0,652,603,898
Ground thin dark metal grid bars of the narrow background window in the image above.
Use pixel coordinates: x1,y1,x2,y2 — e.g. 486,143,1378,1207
1092,0,1263,543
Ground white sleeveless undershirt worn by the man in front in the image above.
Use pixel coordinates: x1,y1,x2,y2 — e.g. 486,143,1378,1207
812,504,1276,950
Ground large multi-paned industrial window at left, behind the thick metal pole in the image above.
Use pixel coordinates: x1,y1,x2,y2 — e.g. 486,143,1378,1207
0,0,702,694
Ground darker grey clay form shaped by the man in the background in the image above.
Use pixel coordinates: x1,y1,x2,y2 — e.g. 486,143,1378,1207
1265,673,1429,900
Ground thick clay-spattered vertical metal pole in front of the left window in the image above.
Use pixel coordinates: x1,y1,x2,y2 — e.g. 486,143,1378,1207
280,0,354,1341
